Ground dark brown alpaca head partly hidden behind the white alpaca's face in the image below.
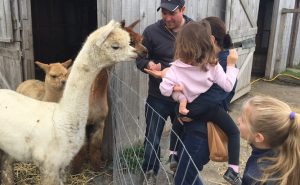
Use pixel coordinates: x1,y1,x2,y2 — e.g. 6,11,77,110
121,20,148,57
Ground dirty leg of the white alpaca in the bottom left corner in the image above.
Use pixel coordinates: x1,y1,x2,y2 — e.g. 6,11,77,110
0,151,14,185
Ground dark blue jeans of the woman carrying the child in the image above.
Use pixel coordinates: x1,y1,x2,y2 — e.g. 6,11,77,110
174,121,209,185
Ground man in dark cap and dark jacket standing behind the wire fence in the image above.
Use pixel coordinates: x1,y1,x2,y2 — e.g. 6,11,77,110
136,0,191,184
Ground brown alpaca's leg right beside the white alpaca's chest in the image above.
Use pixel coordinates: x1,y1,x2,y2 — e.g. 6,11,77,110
70,142,88,174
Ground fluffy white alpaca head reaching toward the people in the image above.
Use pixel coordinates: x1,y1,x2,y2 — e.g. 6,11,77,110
86,20,137,67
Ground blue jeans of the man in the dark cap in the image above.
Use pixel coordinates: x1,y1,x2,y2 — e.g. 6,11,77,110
142,96,176,174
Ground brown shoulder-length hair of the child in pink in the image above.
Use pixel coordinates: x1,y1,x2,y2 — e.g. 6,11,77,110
174,21,218,71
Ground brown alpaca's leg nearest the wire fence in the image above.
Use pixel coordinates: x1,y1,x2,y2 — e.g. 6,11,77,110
89,120,105,171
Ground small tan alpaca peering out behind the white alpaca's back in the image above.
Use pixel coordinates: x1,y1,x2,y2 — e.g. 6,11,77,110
16,59,72,102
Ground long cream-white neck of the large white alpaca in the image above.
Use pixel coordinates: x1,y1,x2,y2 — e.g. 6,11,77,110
59,48,103,124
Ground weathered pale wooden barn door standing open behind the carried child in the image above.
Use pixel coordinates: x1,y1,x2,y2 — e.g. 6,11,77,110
225,0,259,100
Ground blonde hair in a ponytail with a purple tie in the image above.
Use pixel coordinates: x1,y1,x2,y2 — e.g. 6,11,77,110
245,96,300,185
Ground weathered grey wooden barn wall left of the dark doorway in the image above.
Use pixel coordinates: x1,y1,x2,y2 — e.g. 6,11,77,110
0,0,34,90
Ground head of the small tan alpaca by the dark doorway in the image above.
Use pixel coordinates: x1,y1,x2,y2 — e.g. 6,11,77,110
35,59,72,90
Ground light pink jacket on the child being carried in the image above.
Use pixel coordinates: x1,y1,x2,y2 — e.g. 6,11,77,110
159,60,239,102
